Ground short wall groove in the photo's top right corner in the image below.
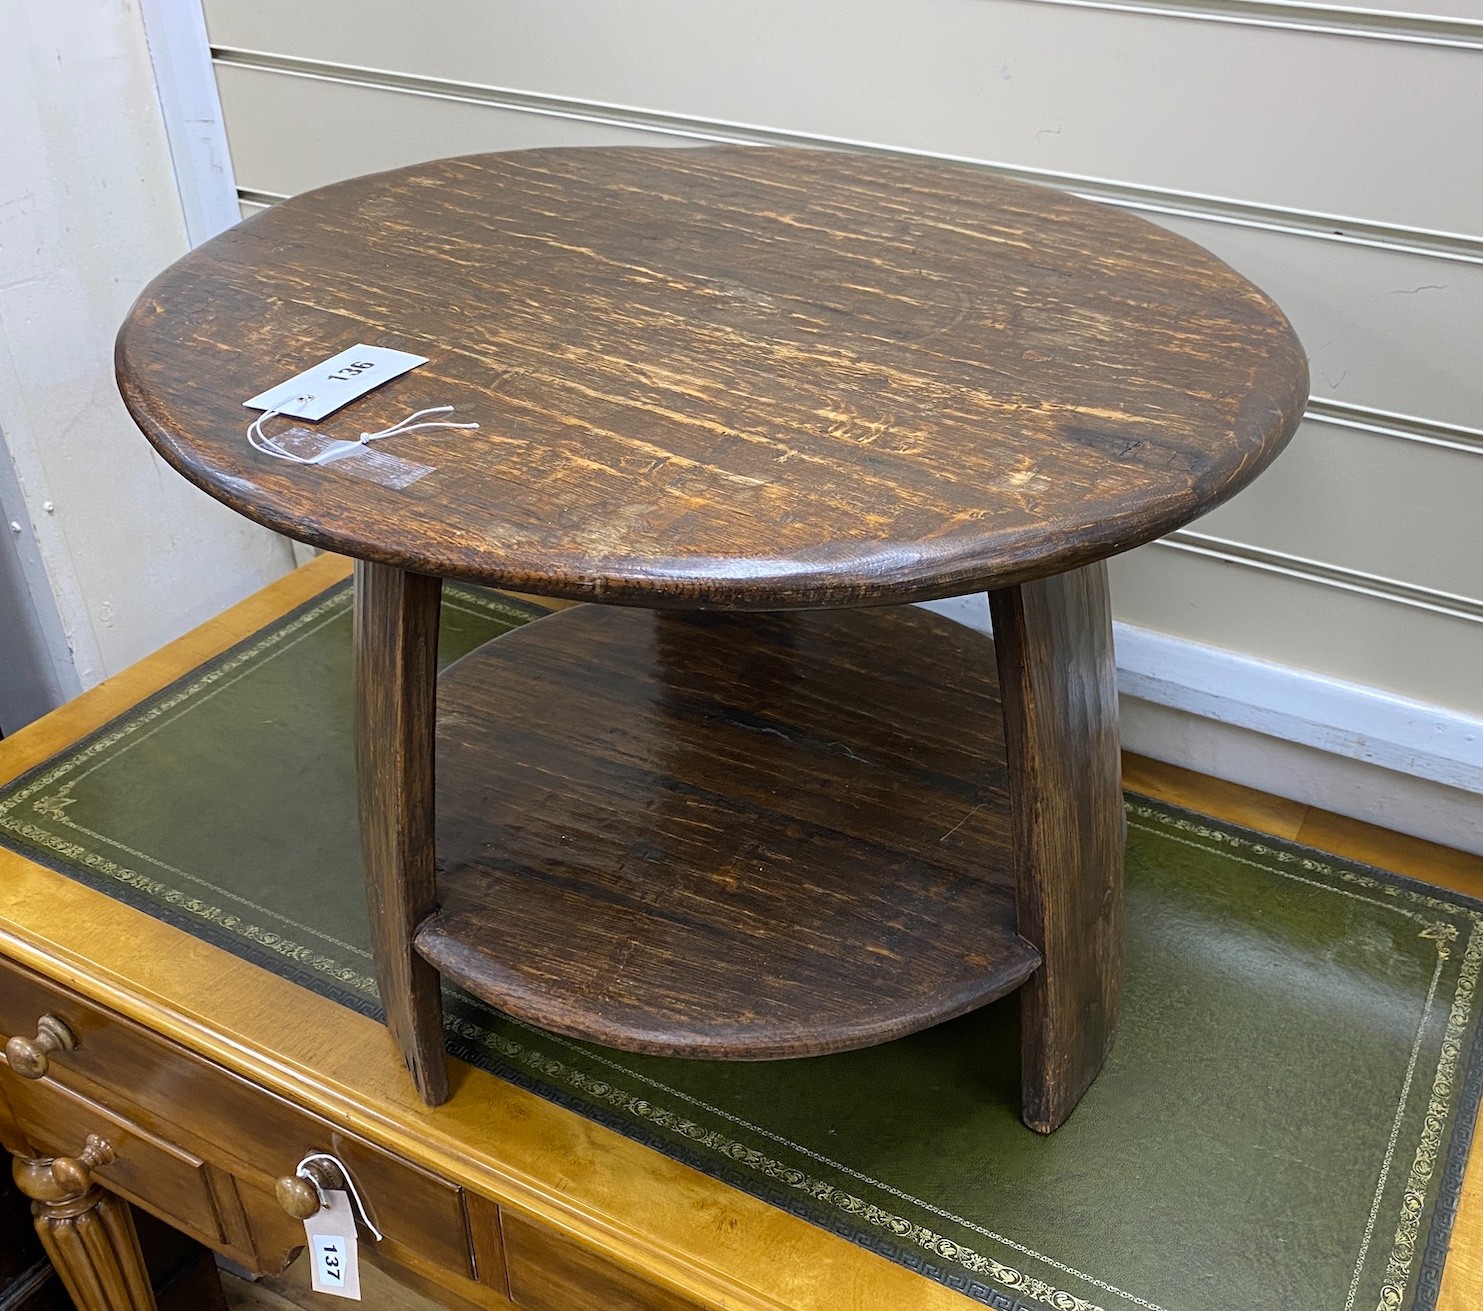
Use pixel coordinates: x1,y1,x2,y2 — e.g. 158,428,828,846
1031,0,1483,50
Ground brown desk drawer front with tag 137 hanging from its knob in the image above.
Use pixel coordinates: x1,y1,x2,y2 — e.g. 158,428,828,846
0,960,473,1277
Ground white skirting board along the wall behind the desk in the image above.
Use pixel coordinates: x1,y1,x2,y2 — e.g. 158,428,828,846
928,596,1483,854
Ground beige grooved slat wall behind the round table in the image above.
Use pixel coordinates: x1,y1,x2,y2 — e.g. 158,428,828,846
206,0,1483,715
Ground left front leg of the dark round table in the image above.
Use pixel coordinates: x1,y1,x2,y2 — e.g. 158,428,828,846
356,561,448,1106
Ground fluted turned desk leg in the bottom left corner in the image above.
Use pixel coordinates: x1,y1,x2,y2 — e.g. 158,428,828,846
12,1135,156,1311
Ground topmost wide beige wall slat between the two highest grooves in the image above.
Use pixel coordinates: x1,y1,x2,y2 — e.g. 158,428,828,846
208,0,1483,236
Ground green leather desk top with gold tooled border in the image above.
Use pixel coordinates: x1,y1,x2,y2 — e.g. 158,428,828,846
0,587,1483,1311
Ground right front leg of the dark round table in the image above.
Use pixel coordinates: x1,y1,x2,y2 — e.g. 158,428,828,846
989,564,1124,1133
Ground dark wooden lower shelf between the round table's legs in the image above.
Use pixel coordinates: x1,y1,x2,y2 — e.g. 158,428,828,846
415,605,1040,1060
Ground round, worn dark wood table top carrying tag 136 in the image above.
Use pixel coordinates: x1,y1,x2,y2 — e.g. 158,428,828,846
117,147,1308,608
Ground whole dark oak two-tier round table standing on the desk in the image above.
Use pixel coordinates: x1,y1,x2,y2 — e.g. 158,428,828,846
117,147,1307,1132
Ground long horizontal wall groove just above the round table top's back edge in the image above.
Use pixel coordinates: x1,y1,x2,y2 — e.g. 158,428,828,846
212,45,1483,264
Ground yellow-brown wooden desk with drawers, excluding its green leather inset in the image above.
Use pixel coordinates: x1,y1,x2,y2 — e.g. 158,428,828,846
0,558,1483,1311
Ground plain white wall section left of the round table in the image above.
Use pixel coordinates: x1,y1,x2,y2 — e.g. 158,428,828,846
0,0,292,728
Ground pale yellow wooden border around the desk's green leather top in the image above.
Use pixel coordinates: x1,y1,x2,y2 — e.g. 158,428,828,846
0,556,1483,1311
